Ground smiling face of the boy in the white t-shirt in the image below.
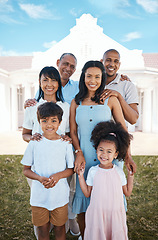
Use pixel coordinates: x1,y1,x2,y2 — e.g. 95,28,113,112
40,116,61,136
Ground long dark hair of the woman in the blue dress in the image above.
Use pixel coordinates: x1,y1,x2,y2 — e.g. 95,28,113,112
75,61,106,105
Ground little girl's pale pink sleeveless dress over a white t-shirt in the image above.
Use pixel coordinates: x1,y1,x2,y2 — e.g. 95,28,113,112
84,167,128,240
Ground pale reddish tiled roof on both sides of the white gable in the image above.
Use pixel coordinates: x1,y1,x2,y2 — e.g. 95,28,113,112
0,53,158,72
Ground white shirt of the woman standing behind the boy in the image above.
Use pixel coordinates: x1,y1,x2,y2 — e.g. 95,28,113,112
23,98,70,135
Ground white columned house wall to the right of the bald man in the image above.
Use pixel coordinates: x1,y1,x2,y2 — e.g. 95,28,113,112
120,68,158,133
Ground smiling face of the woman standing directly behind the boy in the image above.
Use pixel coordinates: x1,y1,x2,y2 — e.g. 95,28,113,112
39,74,59,96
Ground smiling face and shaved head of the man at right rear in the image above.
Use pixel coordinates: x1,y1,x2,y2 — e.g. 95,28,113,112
103,51,120,80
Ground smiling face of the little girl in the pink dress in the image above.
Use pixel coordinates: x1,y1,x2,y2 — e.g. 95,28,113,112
97,141,118,168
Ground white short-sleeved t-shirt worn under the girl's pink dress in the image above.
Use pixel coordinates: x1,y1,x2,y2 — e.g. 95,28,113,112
86,164,127,186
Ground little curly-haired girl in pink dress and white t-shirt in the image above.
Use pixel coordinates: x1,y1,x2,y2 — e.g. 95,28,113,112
78,121,134,240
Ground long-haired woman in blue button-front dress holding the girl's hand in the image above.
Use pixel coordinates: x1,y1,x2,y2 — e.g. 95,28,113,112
70,61,129,237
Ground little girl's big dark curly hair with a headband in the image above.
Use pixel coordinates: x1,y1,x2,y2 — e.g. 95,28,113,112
91,120,133,160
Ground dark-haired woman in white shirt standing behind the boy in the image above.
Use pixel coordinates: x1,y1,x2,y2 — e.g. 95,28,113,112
22,66,70,142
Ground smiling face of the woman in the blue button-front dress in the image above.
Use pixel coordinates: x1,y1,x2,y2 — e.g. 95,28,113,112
85,67,102,92
